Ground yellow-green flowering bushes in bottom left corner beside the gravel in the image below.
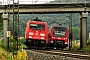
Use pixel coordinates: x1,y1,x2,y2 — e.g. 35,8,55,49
0,48,27,60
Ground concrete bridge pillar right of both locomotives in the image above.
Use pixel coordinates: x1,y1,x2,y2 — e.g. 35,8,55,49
80,12,88,48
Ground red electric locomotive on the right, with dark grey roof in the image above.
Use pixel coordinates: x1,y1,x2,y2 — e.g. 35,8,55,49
49,23,70,49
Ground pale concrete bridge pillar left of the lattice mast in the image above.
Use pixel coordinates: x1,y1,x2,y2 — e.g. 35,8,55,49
2,13,8,47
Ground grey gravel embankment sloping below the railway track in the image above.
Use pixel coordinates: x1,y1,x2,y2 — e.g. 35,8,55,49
27,50,86,60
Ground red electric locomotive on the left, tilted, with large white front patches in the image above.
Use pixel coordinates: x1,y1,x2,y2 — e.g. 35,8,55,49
25,19,48,47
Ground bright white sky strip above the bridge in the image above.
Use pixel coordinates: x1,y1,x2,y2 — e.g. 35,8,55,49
0,0,54,5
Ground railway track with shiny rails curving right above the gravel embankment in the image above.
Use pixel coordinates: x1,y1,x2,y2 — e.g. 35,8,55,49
27,49,90,60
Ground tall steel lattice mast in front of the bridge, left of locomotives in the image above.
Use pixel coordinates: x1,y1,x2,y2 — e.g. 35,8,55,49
13,0,20,55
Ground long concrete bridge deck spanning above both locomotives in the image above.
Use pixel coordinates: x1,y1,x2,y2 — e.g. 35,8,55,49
0,3,90,13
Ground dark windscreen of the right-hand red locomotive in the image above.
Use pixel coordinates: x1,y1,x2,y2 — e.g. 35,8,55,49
54,27,66,37
